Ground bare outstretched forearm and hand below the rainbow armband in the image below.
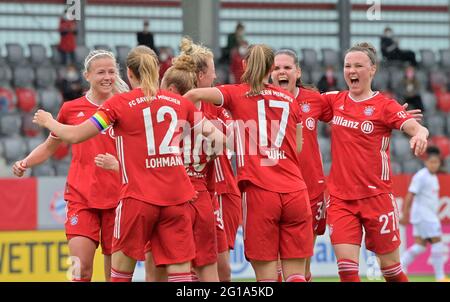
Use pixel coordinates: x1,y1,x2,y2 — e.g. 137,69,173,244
33,110,100,144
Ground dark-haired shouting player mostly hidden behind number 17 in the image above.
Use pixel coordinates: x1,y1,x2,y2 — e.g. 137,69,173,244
271,49,332,281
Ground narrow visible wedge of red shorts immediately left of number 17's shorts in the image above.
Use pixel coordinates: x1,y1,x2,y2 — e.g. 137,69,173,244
217,194,242,250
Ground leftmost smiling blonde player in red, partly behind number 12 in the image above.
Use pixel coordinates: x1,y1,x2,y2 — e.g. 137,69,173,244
13,50,128,281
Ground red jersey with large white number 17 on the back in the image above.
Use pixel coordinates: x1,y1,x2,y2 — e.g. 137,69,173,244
217,84,306,193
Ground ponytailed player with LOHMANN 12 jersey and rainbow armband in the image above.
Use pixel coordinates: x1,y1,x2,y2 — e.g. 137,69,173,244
34,46,223,282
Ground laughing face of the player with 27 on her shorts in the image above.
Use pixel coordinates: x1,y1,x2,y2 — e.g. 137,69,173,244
344,51,376,96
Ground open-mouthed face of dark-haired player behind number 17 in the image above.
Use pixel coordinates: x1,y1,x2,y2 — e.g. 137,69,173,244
271,54,301,94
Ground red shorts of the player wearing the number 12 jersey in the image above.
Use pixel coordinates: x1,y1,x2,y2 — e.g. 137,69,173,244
113,198,195,266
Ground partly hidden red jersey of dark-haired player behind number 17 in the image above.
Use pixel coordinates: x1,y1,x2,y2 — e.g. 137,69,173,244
296,88,333,200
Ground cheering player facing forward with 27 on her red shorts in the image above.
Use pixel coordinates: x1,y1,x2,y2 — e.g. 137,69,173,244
324,43,428,282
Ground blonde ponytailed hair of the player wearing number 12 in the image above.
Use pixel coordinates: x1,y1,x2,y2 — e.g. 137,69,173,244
127,45,159,97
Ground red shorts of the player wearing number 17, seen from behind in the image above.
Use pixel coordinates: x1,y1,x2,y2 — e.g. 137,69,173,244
242,183,313,261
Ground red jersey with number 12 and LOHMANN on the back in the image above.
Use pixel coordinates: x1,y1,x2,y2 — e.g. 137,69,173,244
91,88,201,206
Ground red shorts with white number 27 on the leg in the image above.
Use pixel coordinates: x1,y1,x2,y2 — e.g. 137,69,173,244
327,194,400,255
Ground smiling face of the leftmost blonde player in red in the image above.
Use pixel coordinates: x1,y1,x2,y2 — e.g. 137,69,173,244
85,57,117,94
